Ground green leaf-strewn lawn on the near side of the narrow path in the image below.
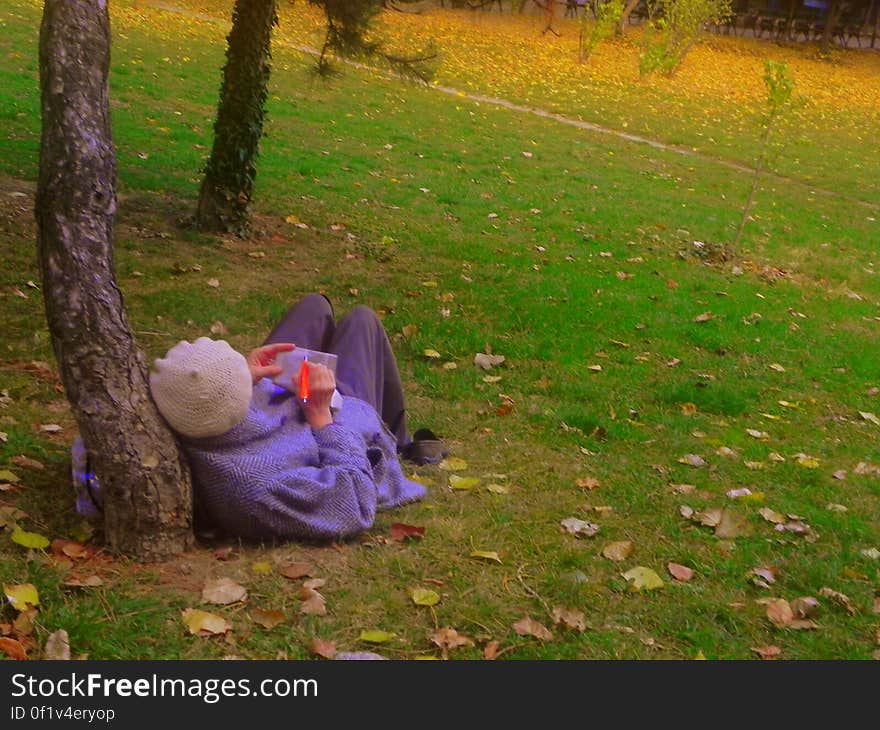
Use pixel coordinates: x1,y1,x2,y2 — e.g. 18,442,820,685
0,0,880,659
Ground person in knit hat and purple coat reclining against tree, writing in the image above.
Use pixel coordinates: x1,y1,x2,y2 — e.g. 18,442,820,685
150,294,445,540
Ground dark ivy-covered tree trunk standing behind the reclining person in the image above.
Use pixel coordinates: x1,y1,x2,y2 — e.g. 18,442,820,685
196,0,278,235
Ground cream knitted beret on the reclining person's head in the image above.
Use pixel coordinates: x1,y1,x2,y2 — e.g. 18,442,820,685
150,337,253,438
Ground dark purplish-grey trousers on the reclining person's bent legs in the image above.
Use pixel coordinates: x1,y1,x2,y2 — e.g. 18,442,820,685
263,294,410,448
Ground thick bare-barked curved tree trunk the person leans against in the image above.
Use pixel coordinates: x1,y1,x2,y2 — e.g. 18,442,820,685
36,0,193,560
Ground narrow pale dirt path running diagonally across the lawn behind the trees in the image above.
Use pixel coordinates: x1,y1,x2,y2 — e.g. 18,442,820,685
144,0,880,210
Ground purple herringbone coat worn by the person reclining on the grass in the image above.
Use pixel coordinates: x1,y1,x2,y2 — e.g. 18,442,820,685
183,378,425,540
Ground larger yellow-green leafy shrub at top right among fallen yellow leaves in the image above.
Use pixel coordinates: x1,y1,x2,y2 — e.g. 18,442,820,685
639,0,731,76
